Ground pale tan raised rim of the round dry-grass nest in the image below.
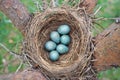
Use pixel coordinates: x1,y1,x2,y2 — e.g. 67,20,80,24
24,8,90,78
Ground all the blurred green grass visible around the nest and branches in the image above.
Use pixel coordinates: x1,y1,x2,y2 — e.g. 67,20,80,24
0,0,120,80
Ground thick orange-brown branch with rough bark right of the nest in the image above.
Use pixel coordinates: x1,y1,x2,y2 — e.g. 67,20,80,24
94,23,120,71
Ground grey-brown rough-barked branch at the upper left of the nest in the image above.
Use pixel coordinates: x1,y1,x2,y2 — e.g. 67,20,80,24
0,0,30,34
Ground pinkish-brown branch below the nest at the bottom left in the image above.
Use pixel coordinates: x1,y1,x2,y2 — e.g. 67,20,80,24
0,69,47,80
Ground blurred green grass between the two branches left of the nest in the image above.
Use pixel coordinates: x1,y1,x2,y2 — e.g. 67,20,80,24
0,13,22,73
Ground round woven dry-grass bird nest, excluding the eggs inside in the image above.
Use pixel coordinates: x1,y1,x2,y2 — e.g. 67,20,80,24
24,8,93,80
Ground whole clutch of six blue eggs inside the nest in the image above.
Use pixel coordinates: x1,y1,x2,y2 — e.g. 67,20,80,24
44,25,71,61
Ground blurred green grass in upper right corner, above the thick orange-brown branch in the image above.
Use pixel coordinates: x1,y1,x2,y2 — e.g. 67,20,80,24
93,0,120,35
